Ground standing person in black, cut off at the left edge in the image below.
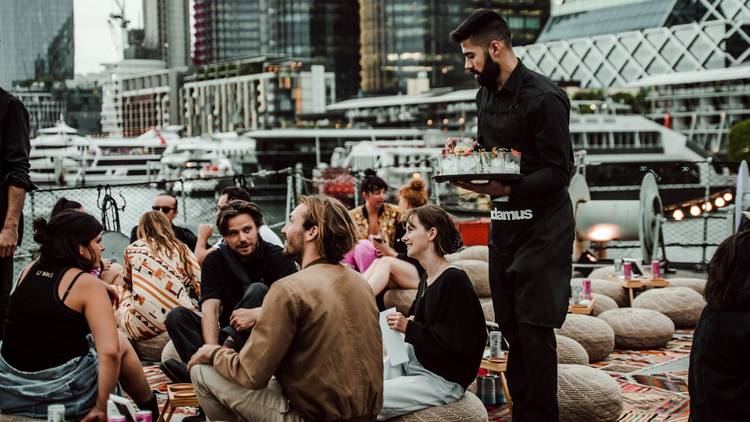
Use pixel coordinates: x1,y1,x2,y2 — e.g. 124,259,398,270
0,88,34,340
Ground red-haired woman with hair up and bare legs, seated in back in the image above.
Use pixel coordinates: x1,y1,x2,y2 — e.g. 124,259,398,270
363,177,427,302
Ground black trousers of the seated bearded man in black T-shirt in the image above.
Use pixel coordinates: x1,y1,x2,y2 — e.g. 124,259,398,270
164,283,268,363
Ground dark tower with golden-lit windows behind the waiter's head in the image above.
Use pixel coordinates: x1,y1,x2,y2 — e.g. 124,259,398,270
360,0,550,93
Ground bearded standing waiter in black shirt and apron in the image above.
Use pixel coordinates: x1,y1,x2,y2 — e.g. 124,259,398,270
451,10,574,422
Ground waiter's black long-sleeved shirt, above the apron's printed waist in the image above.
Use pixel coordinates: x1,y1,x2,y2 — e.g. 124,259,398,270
476,60,573,198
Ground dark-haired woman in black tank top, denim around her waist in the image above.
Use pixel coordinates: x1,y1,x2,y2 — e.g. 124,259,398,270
0,211,158,422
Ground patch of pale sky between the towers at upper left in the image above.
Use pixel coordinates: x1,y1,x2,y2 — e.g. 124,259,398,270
73,0,143,75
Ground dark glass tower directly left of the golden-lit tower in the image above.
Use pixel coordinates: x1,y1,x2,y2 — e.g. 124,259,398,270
265,0,359,99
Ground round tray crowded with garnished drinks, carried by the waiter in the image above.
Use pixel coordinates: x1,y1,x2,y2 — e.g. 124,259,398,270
433,138,522,185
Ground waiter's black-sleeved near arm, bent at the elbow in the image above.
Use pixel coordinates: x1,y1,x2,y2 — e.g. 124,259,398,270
511,92,573,198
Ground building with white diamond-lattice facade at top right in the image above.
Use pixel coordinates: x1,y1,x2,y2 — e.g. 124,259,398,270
515,0,750,88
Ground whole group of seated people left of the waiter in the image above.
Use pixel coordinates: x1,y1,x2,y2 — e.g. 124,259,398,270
0,172,494,421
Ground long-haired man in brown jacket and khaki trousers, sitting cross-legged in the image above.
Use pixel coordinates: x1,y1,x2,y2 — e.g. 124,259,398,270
190,196,383,421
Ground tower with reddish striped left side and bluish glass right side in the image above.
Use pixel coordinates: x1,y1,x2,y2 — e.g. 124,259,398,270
193,0,266,66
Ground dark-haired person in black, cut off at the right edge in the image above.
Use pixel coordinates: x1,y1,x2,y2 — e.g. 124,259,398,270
688,231,750,422
